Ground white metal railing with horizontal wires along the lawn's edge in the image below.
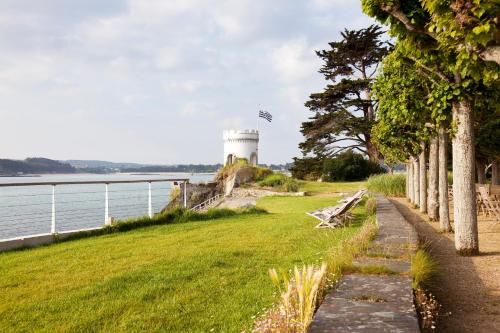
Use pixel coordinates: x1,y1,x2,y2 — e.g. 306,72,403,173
0,178,189,240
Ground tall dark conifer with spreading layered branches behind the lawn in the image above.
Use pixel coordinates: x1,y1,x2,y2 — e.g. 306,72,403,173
300,25,390,161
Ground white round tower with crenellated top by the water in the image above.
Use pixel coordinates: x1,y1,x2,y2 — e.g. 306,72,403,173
223,130,259,165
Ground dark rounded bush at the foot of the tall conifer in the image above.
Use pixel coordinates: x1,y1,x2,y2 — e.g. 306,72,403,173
323,150,385,181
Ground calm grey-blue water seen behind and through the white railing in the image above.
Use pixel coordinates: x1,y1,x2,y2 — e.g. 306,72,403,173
0,173,213,240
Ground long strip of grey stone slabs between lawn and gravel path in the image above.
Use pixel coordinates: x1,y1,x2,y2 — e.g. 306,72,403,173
308,196,419,333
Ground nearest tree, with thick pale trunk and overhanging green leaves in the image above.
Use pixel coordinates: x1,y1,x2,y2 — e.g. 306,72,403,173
362,0,500,255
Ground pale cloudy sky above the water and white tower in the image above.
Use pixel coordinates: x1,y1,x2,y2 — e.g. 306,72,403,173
0,0,374,164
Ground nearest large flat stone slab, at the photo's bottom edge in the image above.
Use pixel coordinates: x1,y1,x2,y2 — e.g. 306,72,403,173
308,274,419,333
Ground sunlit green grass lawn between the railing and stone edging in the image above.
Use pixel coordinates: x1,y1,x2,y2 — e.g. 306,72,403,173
0,184,363,332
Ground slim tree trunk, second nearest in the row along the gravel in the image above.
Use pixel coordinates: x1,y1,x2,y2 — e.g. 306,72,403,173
438,127,451,232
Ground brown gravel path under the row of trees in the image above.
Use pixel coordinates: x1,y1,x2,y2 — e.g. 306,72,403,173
391,198,500,333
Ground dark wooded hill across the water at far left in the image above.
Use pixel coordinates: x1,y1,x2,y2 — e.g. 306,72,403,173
0,157,77,175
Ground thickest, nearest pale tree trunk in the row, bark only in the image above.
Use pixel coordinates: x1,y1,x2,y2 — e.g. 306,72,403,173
453,99,479,255
